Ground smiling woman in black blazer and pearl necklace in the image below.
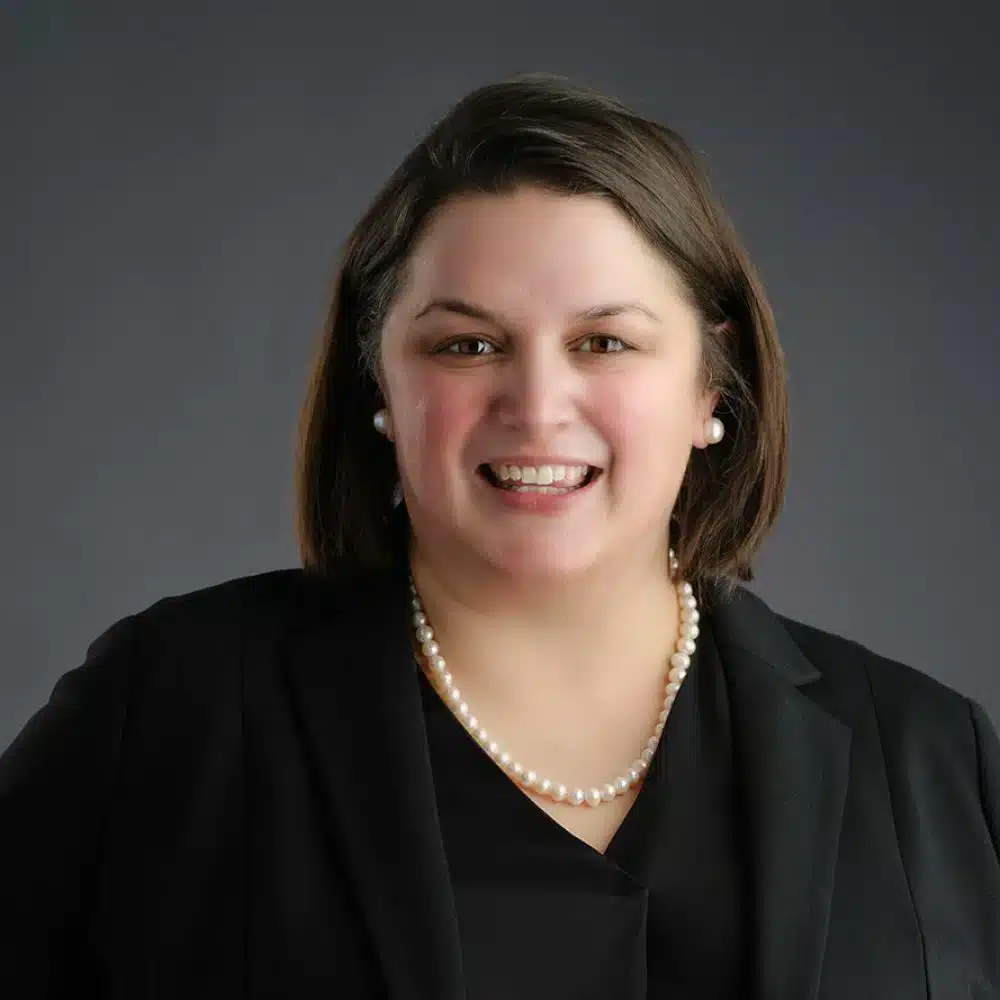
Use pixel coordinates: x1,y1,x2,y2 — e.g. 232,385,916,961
0,76,1000,1000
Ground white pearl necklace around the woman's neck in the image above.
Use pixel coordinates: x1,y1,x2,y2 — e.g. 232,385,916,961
410,549,699,808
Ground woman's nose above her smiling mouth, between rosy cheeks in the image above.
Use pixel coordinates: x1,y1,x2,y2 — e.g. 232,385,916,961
496,339,580,439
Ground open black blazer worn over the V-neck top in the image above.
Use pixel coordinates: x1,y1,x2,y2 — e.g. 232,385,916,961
0,570,1000,1000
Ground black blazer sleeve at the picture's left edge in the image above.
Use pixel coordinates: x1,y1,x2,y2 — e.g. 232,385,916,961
0,615,135,1000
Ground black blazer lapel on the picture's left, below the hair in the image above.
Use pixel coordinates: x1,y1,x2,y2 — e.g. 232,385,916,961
285,570,465,1000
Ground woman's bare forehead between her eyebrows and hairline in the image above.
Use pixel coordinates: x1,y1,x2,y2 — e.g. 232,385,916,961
404,188,684,312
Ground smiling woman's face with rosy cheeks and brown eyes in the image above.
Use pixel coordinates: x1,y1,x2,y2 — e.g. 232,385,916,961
382,188,717,581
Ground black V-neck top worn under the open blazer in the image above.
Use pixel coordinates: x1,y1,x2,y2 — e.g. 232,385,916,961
420,616,749,1000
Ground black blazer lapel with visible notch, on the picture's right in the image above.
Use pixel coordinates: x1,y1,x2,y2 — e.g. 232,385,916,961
711,587,851,1000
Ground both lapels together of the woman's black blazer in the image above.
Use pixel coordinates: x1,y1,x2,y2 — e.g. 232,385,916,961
283,568,850,1000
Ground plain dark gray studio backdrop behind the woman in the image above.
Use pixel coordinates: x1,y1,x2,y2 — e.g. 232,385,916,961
0,0,1000,748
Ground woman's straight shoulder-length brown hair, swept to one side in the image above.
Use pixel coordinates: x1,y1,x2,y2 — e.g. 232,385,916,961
295,74,788,600
